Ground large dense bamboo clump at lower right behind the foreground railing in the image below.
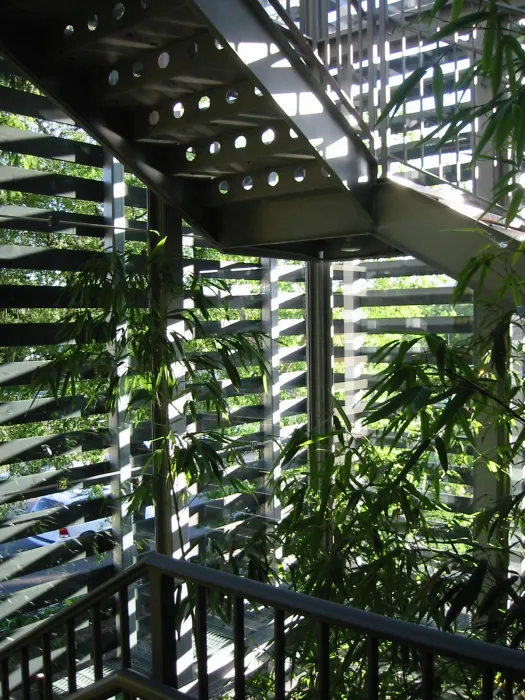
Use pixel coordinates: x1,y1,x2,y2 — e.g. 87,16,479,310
207,246,525,700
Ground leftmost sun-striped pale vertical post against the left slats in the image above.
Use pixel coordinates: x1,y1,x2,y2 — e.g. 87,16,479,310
103,154,137,660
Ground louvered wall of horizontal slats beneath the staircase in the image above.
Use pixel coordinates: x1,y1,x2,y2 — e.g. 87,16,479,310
0,13,470,688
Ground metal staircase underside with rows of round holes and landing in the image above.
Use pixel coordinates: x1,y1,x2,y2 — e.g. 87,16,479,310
0,0,520,292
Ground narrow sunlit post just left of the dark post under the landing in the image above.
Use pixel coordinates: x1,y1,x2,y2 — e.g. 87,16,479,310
261,258,281,520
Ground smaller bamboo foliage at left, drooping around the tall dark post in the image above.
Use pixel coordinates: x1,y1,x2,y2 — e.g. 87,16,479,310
35,234,267,556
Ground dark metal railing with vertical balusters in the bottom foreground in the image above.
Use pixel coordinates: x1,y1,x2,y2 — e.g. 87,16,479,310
0,553,525,700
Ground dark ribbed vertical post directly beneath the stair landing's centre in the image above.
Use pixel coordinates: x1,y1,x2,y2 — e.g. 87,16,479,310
306,260,333,434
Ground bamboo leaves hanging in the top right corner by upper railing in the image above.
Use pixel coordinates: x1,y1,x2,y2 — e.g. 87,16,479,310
380,0,525,226
